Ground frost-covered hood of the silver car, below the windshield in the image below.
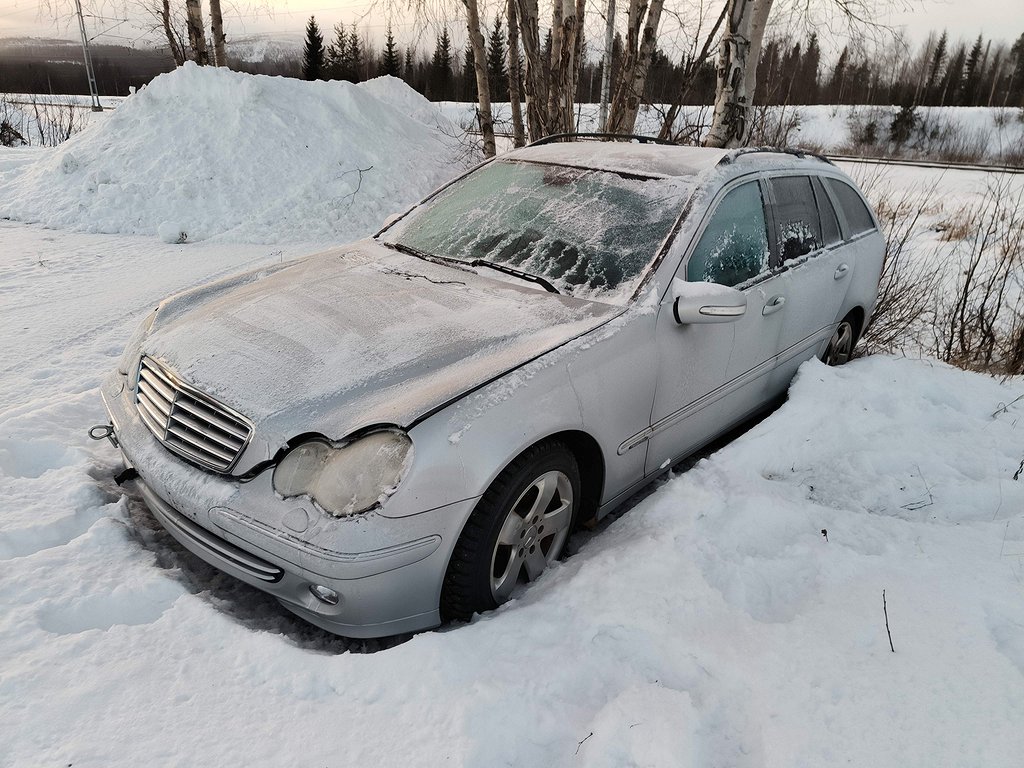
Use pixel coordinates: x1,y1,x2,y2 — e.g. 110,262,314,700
143,241,623,453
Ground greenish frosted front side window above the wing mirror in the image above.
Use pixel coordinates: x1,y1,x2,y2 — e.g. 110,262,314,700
686,181,769,286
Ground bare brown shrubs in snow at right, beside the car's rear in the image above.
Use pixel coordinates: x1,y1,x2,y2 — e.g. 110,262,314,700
860,175,1024,376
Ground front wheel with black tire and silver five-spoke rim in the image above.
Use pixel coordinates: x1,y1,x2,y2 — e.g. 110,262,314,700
440,440,581,621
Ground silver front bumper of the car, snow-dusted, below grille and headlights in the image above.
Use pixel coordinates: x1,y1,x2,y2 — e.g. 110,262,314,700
101,374,476,638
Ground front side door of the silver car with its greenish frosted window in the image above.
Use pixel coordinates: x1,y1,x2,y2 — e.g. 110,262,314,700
646,179,781,474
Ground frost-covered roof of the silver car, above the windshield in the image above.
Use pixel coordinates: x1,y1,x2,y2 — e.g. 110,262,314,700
502,141,828,177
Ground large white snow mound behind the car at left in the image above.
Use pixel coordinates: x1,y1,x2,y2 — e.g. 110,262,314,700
0,65,462,243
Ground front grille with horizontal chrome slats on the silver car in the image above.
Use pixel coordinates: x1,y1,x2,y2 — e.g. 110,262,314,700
135,356,253,472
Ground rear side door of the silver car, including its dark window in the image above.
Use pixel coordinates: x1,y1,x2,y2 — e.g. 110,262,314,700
768,174,853,394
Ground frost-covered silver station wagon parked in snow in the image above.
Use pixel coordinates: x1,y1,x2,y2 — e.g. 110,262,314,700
94,142,883,637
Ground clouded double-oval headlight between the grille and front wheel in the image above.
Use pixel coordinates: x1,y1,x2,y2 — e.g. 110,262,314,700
273,431,413,517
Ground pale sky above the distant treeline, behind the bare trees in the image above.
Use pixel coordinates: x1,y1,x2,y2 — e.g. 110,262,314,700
0,0,1024,53
